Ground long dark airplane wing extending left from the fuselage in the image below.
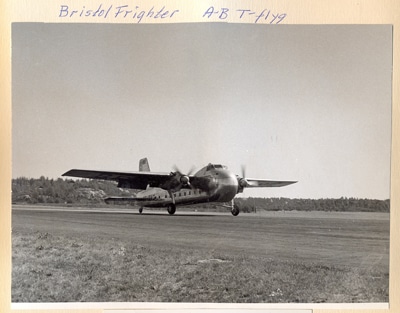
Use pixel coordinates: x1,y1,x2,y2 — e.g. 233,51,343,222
62,169,177,189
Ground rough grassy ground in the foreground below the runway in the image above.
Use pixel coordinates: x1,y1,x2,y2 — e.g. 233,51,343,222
12,232,388,303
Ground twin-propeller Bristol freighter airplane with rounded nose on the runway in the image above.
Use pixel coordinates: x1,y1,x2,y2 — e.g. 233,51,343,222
62,158,297,216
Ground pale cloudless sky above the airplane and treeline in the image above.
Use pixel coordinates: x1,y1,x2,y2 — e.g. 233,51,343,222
12,23,392,199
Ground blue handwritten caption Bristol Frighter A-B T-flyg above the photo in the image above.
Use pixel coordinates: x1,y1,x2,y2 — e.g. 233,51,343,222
58,4,286,24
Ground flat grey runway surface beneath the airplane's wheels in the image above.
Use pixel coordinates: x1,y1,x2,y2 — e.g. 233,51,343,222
12,206,389,271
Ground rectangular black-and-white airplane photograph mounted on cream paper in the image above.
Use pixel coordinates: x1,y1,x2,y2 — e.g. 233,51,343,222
11,22,393,304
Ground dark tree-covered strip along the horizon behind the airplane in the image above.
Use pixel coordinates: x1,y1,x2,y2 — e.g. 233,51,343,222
12,176,390,213
